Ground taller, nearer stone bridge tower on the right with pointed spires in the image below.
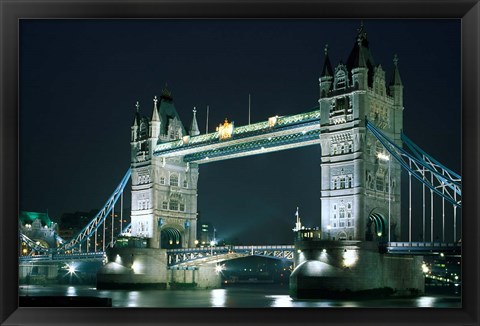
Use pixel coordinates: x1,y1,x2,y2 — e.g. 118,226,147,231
319,24,403,241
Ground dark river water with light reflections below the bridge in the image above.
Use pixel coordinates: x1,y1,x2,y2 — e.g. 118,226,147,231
19,284,461,308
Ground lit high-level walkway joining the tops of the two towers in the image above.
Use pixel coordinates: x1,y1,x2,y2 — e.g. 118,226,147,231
154,109,320,163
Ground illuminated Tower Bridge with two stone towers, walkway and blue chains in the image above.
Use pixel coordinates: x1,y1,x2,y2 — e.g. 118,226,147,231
18,26,462,296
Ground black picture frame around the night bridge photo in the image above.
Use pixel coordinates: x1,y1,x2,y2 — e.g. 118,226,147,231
0,0,480,325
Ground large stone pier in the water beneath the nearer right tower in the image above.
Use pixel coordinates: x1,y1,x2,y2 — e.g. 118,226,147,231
290,241,425,299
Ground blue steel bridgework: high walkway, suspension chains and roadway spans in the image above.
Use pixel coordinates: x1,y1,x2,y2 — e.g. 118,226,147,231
19,110,461,265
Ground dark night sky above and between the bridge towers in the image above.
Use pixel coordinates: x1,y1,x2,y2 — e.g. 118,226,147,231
19,20,461,243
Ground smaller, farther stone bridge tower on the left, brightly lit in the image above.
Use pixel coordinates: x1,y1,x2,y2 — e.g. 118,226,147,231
130,88,199,249
